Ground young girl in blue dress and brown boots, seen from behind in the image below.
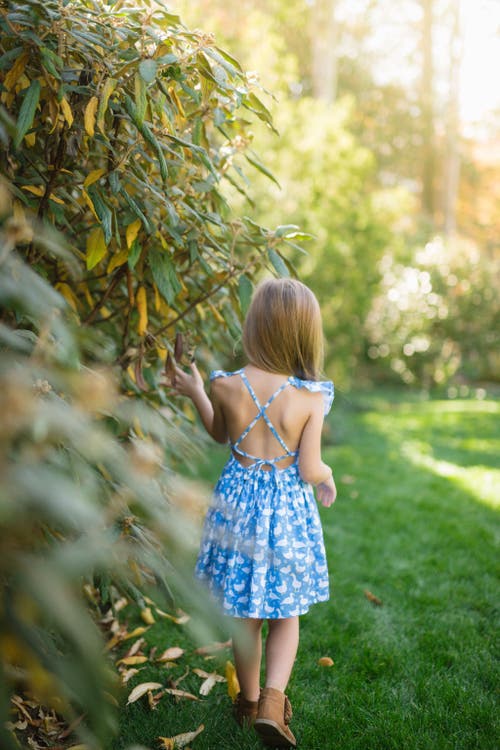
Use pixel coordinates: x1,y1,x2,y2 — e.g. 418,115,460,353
168,279,336,747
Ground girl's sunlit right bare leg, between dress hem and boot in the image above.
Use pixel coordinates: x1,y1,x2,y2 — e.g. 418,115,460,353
266,617,299,693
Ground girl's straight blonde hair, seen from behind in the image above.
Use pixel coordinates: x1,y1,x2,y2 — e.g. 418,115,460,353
243,279,323,380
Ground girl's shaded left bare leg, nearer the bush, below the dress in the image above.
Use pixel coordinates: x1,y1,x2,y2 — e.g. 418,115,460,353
233,618,263,701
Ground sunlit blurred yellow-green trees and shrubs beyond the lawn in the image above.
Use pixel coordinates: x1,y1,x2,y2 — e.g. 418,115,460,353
178,0,500,388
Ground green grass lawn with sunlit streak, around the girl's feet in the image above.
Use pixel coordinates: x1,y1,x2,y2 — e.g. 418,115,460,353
114,392,500,750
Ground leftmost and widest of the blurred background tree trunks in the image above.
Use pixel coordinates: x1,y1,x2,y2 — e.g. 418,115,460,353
311,0,338,104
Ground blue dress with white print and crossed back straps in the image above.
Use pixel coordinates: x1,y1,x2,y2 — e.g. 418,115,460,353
195,370,333,619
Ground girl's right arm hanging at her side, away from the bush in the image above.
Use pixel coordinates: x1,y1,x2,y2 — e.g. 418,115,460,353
299,394,337,507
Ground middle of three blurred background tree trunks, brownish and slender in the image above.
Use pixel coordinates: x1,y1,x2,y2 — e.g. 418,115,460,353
421,0,436,226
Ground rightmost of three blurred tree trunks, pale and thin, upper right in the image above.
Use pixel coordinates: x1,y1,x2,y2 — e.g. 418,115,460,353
443,2,462,237
